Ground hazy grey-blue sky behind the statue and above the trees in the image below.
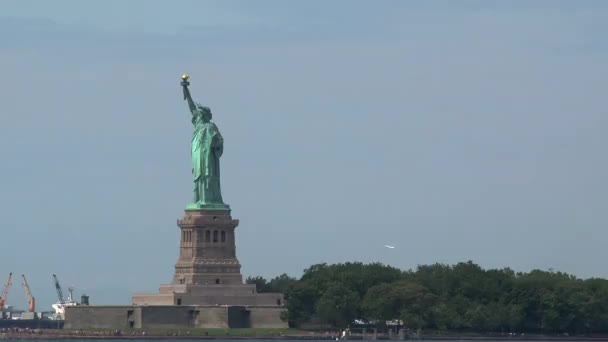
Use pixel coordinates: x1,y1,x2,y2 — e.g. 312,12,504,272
0,0,608,309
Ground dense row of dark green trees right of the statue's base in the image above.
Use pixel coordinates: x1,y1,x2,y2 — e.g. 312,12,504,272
247,261,608,334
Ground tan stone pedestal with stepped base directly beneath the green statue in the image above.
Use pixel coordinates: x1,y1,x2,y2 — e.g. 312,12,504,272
132,209,284,308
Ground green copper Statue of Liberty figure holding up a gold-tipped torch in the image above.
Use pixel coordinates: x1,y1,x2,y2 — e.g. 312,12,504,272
181,74,229,209
